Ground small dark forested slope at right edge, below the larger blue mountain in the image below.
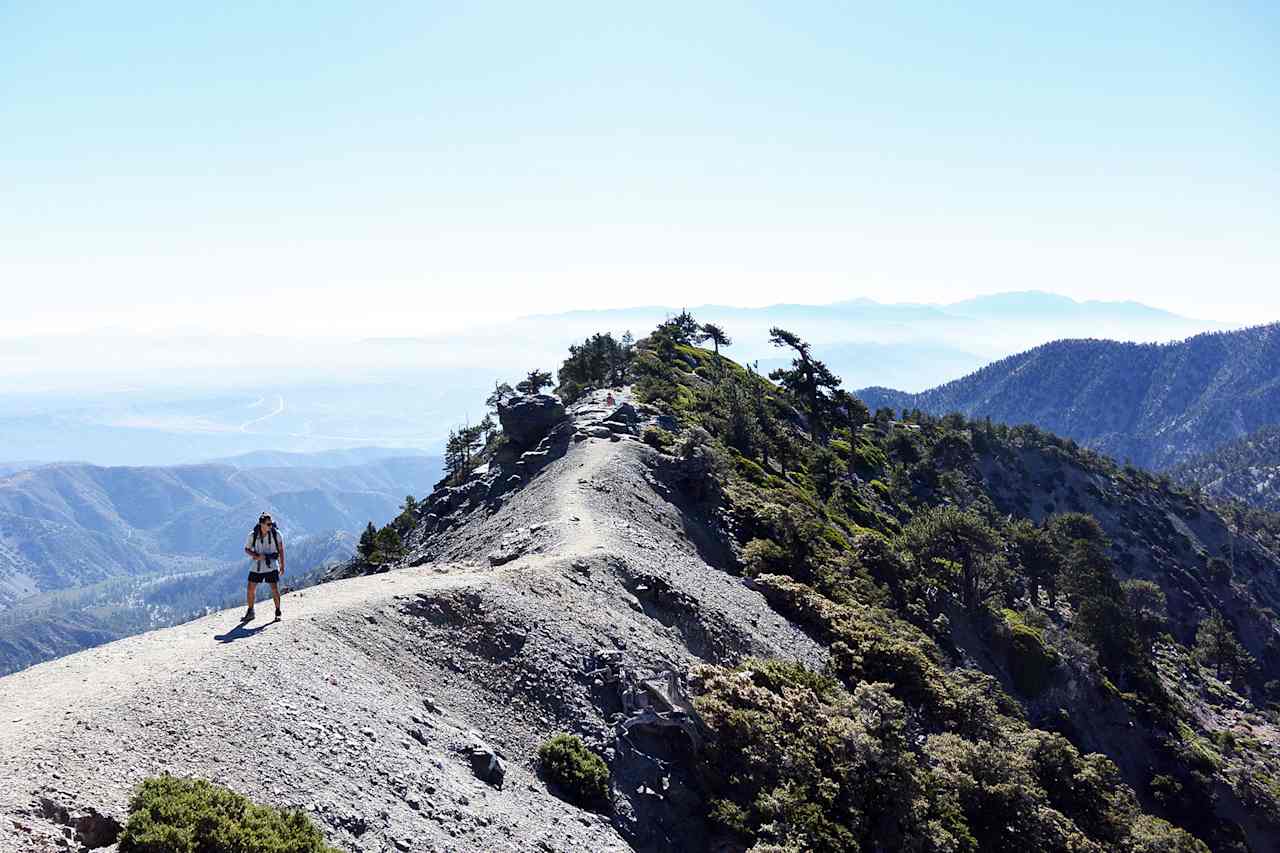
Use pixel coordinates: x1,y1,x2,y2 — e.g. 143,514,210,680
1170,425,1280,512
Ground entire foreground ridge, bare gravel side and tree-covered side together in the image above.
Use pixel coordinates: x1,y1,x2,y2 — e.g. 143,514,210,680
0,319,1280,853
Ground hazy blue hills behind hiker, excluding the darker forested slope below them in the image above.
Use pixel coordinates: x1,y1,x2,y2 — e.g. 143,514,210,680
0,456,440,608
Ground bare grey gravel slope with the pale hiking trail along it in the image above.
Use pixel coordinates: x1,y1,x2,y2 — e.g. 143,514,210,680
0,394,826,850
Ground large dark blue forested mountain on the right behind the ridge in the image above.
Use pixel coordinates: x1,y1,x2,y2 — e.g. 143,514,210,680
858,324,1280,469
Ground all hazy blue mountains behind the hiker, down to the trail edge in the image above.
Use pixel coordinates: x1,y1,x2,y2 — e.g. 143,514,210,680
0,447,442,674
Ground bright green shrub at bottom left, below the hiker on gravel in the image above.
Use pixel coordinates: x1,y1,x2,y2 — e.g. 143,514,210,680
120,776,338,853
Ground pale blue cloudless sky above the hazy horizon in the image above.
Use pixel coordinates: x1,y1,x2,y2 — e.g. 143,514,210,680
0,0,1280,334
